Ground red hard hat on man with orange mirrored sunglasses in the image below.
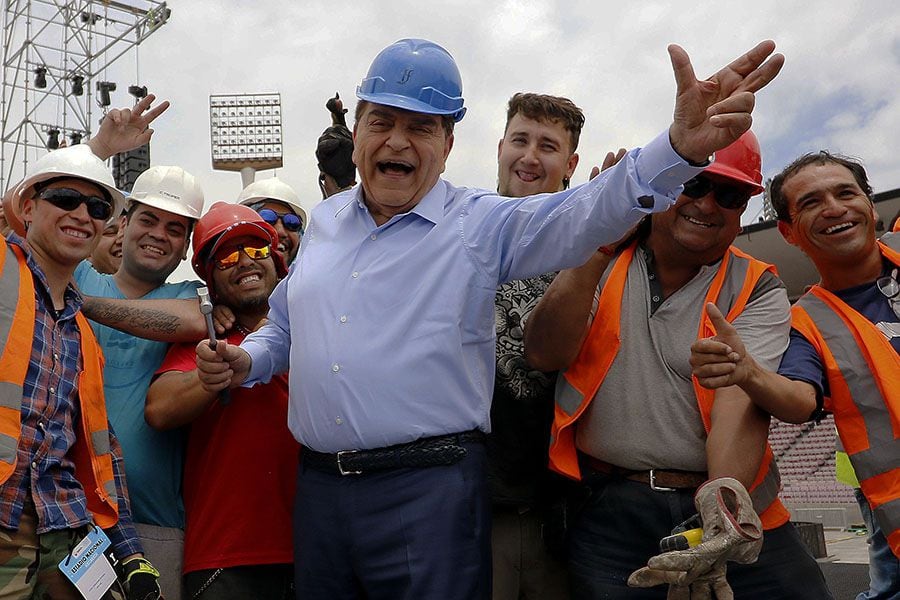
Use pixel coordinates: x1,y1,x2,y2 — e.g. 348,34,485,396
191,202,287,283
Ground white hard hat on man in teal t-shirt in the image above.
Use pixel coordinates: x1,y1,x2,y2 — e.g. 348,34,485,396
128,166,203,220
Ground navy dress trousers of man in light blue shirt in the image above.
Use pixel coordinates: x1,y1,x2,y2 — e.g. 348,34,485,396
294,443,491,600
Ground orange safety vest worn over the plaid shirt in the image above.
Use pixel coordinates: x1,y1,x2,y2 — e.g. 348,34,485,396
0,240,119,528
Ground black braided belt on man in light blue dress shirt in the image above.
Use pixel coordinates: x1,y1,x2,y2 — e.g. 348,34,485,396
300,429,484,475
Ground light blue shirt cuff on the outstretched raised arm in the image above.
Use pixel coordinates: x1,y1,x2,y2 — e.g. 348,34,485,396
635,129,709,212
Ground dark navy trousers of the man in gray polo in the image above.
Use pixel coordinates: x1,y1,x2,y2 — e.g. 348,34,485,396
569,475,832,600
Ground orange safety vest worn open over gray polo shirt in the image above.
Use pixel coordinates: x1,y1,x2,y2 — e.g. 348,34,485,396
550,243,790,529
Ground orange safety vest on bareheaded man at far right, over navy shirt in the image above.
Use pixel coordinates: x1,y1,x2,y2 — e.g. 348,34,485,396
792,233,900,556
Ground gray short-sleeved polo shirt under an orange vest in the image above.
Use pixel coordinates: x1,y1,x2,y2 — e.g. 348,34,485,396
575,248,790,471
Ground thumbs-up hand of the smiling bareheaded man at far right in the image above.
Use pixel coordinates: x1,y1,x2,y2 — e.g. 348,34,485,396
691,303,753,389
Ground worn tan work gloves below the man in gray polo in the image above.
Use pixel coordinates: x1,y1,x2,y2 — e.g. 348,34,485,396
628,477,763,600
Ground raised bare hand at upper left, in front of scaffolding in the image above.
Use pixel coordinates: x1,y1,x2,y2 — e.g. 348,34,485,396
88,94,169,160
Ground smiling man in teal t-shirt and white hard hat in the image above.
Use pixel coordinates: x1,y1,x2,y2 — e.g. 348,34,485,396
75,161,203,598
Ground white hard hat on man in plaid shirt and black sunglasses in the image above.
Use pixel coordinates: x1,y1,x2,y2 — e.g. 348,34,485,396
16,144,125,218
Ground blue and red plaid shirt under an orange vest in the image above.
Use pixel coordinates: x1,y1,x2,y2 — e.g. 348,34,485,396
0,234,143,558
